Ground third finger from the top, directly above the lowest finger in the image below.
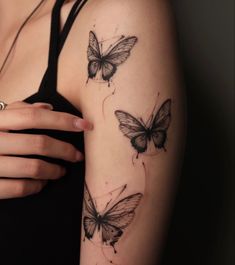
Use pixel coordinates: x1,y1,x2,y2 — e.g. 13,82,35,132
0,156,66,180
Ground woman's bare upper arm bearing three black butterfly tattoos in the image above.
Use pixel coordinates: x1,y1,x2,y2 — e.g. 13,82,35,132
73,0,185,265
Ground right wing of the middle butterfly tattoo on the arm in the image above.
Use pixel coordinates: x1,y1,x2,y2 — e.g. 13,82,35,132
151,99,171,148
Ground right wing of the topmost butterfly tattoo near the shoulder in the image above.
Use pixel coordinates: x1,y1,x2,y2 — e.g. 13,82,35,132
101,37,137,81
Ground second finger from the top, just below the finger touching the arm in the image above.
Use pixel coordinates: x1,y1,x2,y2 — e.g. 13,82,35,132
0,132,83,162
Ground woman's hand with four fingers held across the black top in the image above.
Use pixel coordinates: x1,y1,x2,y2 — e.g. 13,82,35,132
0,102,92,199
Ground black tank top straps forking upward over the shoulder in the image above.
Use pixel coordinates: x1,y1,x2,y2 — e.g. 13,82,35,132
39,0,87,95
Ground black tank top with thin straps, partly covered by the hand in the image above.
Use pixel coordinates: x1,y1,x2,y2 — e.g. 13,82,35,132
0,0,87,265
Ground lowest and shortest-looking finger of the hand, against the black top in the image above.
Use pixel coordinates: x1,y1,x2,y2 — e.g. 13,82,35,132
0,179,47,200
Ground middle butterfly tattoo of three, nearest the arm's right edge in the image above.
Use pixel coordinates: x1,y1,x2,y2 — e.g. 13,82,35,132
115,99,171,157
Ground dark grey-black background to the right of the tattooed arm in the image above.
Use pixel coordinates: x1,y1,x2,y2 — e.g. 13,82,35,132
162,0,235,265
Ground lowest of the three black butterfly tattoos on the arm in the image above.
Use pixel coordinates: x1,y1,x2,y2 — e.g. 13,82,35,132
83,183,143,253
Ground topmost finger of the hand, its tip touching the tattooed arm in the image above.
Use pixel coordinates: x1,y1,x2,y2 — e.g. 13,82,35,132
0,104,93,132
